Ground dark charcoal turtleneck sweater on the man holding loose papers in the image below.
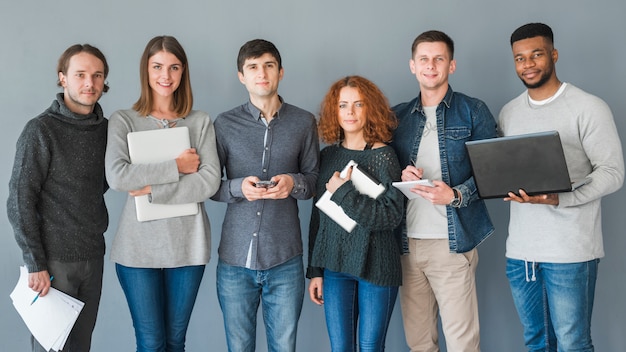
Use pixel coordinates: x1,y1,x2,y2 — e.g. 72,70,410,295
7,93,109,272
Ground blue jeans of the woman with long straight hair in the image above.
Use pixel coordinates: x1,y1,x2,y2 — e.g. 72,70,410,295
115,264,205,352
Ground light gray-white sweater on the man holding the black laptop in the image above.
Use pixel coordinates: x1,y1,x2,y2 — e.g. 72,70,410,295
499,84,624,263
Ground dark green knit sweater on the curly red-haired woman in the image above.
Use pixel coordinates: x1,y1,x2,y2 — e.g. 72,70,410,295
307,145,404,286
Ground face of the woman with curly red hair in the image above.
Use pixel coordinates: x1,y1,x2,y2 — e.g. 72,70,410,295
337,87,366,136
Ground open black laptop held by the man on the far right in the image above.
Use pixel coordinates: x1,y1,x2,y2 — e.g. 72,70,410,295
465,131,591,198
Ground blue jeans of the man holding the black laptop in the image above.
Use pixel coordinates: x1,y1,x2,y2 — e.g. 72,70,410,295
506,259,600,352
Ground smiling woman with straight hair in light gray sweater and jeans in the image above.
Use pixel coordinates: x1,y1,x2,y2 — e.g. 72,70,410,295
105,36,221,351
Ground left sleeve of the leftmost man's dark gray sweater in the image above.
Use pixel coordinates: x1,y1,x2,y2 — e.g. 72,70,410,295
7,120,50,272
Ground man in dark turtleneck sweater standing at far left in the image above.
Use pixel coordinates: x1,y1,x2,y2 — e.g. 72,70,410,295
7,44,109,352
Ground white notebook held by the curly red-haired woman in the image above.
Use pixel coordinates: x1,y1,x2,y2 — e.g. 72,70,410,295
315,160,385,232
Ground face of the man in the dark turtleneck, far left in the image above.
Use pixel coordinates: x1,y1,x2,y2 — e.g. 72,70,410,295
59,52,105,115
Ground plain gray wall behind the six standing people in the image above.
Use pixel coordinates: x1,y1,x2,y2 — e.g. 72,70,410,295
0,0,626,352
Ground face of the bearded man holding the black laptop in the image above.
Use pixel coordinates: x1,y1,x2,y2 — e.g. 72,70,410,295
512,36,559,89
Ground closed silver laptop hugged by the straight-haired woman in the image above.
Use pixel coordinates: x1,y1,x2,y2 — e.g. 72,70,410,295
127,126,198,221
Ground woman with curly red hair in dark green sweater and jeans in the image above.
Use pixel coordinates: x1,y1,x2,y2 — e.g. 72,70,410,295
307,76,404,351
